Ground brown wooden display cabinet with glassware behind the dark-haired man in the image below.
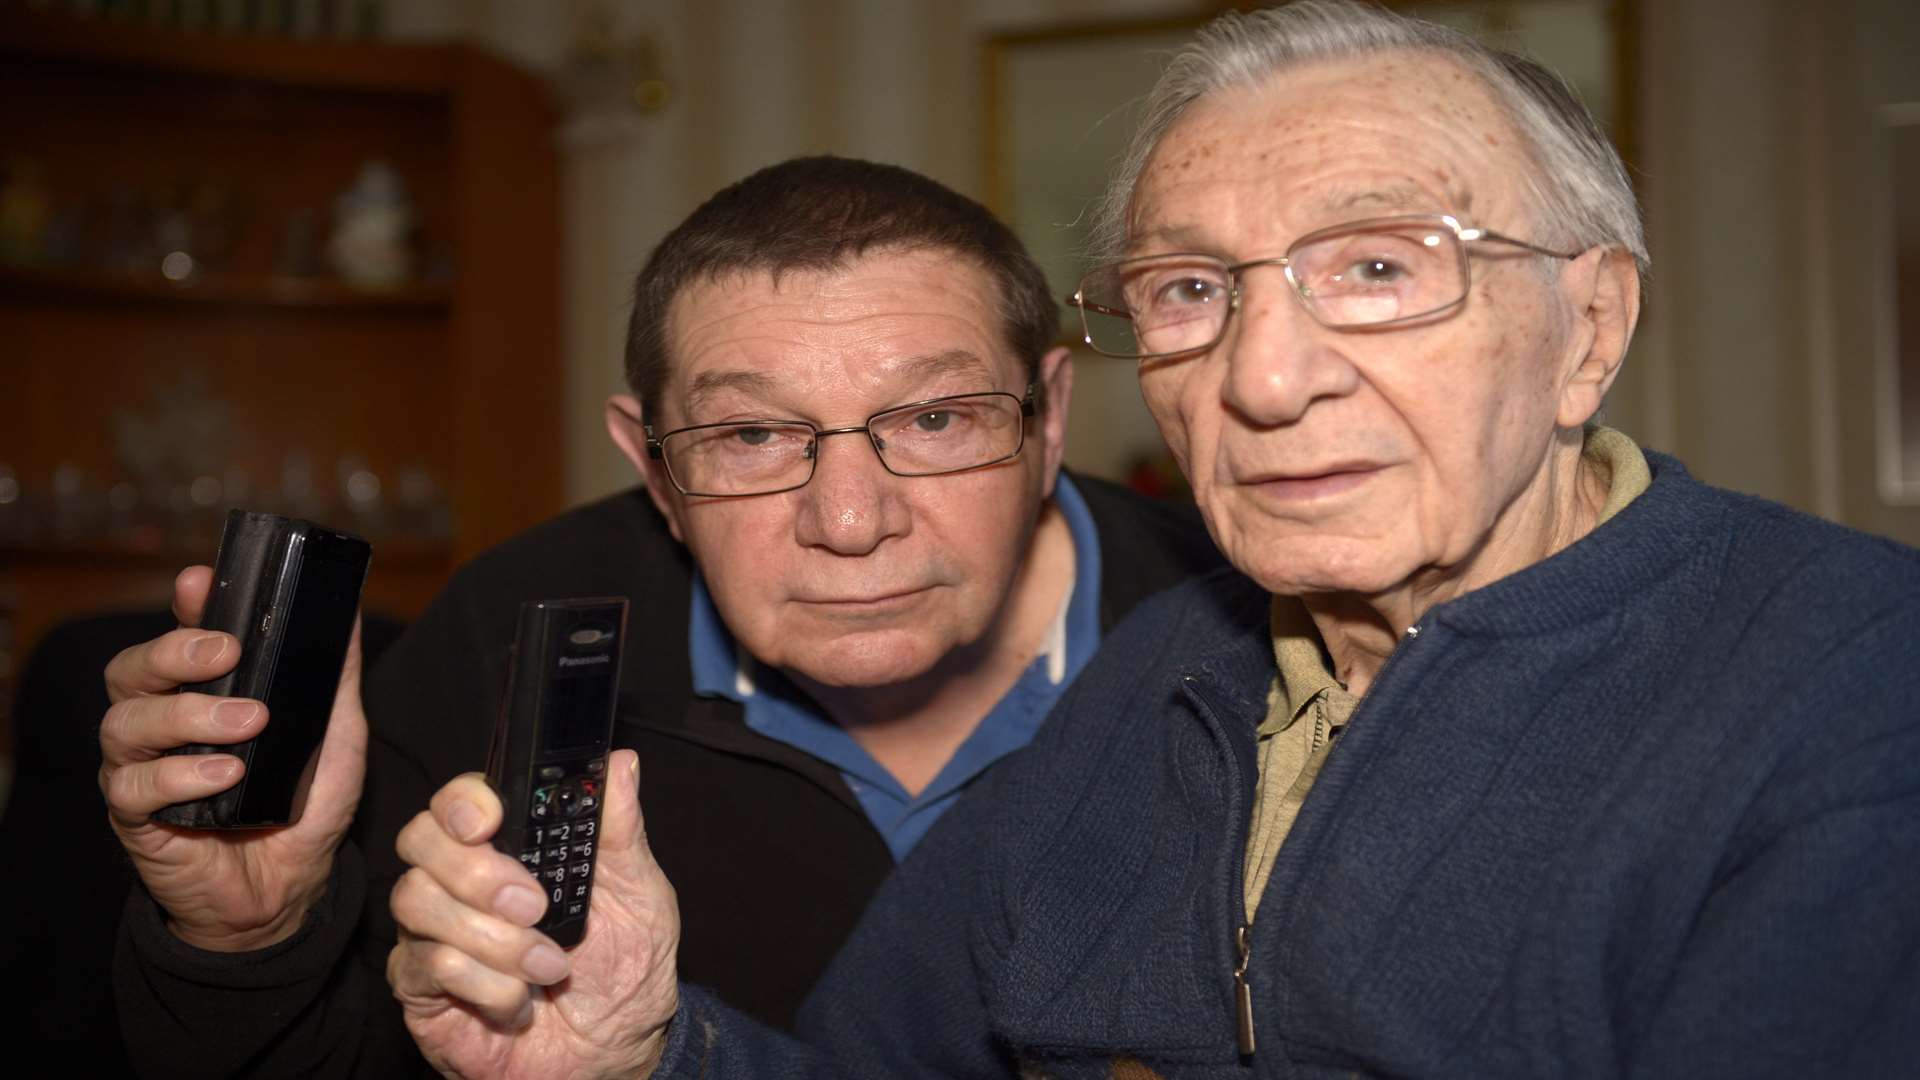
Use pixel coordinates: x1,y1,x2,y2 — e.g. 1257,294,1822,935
0,4,564,699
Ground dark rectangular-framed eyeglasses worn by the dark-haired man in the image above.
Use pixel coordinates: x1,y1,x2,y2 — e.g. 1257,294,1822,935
641,382,1035,498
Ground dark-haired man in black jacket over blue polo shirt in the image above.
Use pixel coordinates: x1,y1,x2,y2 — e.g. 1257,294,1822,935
102,158,1217,1074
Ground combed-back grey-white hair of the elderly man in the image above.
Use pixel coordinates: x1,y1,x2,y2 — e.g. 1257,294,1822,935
1091,0,1647,277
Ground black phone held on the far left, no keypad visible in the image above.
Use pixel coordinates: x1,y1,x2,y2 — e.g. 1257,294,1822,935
154,509,372,828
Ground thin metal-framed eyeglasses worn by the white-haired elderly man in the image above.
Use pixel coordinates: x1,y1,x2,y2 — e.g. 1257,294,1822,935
1068,213,1580,359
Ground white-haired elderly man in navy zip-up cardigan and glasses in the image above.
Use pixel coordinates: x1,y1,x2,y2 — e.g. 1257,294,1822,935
378,0,1920,1078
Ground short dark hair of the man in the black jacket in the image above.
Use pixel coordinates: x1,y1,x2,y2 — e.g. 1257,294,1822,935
626,158,1060,417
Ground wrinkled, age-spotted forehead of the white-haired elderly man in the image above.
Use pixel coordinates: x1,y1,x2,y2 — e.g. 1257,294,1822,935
1127,52,1534,254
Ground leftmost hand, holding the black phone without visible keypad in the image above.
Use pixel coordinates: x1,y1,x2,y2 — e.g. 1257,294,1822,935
100,567,367,951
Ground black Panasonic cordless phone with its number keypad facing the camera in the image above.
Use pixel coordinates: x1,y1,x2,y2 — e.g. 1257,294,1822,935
486,598,626,949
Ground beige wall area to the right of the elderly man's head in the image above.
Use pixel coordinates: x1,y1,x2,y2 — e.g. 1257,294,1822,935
1613,0,1920,544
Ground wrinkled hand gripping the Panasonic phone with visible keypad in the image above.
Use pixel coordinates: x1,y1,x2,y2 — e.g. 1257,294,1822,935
386,749,680,1078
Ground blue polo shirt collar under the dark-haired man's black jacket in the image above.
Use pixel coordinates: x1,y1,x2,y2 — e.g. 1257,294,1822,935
687,473,1100,861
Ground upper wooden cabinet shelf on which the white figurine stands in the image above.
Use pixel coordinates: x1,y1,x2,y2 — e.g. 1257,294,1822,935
0,263,453,315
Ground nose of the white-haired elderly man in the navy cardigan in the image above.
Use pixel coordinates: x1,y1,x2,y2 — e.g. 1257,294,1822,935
1221,267,1359,427
